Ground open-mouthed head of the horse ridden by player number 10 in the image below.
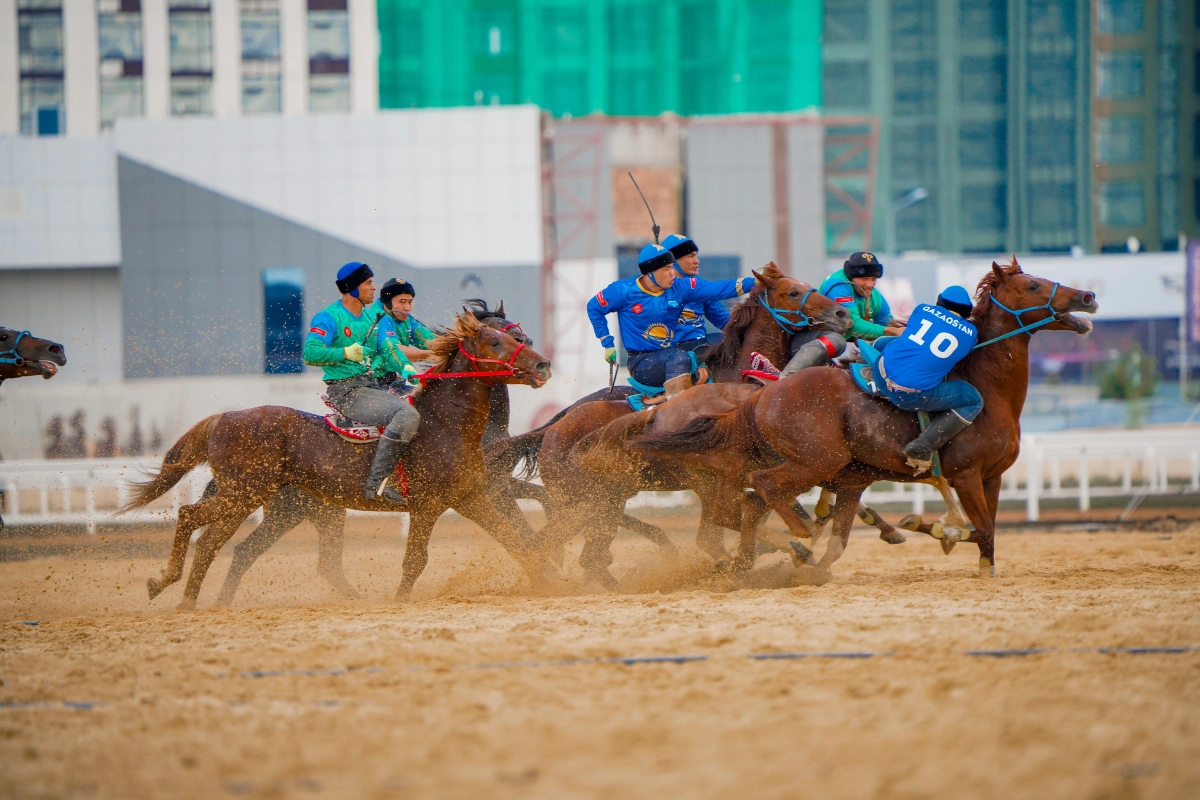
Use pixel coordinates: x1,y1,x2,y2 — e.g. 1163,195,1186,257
972,255,1099,338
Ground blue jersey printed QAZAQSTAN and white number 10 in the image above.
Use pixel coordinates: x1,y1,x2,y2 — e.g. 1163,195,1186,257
883,306,979,391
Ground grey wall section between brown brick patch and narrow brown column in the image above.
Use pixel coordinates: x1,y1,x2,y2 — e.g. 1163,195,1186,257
686,122,775,275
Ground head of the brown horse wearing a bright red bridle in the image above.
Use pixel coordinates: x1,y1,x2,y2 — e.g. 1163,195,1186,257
430,313,551,389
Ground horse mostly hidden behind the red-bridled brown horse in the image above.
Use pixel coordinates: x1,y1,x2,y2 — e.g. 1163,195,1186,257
200,297,546,606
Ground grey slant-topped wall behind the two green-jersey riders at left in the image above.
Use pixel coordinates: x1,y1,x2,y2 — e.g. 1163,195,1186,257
118,157,540,378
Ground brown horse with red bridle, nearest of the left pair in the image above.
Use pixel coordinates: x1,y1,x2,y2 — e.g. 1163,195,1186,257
126,314,550,608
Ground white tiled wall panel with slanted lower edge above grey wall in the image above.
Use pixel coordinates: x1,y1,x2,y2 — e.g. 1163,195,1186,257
115,106,542,266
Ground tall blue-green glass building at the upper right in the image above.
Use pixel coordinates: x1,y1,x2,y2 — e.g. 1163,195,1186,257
822,0,1180,253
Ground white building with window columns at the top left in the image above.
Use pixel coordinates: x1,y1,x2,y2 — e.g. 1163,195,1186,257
0,0,378,137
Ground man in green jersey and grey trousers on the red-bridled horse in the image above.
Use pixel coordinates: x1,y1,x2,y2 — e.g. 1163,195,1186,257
304,261,421,505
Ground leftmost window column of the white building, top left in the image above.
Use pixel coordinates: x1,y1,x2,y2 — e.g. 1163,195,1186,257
17,0,66,136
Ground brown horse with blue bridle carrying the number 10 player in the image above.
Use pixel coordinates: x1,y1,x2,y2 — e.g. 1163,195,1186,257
631,258,1097,576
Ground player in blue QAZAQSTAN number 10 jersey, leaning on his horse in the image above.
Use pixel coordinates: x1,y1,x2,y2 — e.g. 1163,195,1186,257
875,287,983,475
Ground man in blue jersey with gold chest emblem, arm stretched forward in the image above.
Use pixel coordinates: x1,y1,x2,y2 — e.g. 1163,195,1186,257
588,245,755,398
